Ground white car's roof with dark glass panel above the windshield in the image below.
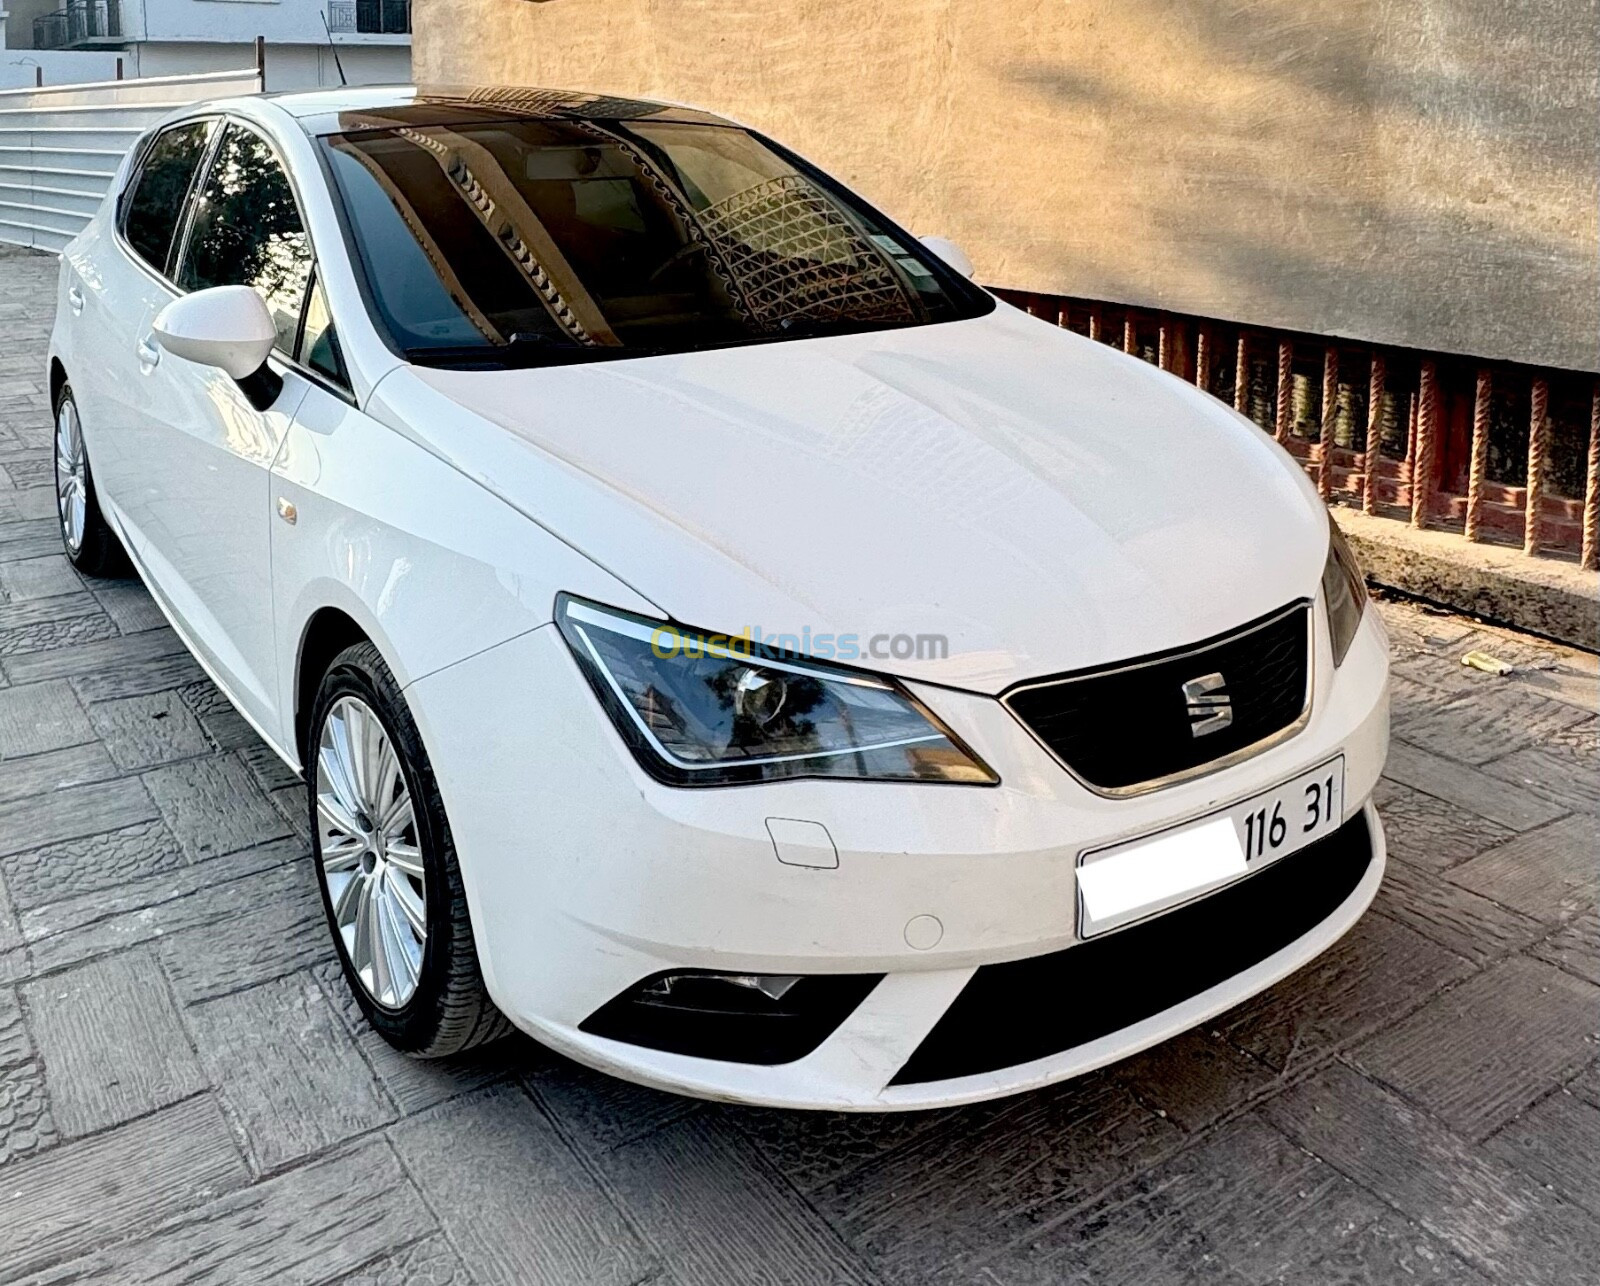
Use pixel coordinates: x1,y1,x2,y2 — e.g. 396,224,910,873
261,85,733,136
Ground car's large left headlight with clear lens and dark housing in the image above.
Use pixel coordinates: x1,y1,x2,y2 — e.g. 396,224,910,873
555,593,1000,785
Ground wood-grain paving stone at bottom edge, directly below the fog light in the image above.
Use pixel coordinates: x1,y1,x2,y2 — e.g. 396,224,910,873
598,1116,869,1286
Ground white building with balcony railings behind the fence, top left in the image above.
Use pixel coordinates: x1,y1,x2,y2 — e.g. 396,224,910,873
14,0,411,90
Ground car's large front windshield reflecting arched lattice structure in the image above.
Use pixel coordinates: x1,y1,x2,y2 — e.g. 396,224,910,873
323,118,994,366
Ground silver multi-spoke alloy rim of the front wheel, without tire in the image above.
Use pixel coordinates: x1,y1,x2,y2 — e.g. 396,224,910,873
315,696,427,1009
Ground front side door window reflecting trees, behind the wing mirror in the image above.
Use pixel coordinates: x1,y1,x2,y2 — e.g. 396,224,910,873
178,125,310,353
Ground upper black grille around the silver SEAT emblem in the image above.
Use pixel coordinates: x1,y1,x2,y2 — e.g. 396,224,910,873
1003,601,1310,795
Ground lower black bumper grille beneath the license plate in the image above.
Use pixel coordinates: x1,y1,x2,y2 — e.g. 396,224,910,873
893,814,1373,1084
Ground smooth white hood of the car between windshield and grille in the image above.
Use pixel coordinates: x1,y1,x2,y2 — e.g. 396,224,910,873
368,306,1326,693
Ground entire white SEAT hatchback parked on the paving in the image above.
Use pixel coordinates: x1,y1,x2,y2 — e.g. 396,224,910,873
50,88,1389,1110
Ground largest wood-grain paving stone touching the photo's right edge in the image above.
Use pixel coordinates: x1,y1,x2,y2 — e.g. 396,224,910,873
1350,958,1600,1139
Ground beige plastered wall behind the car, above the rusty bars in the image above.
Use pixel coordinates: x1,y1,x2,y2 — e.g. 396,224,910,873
414,0,1600,369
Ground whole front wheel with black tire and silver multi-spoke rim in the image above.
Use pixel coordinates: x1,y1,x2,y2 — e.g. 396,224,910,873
306,643,512,1059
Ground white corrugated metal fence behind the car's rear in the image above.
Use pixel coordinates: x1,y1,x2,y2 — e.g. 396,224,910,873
0,67,261,250
